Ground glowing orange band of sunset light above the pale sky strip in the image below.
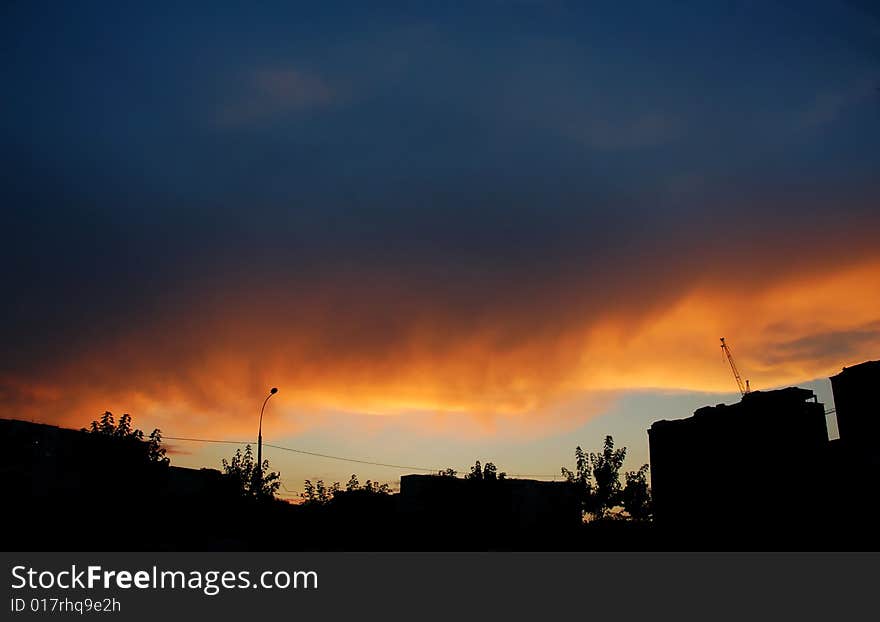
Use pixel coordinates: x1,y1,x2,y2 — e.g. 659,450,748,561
3,251,880,436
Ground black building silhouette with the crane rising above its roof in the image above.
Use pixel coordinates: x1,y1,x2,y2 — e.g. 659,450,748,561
648,387,828,531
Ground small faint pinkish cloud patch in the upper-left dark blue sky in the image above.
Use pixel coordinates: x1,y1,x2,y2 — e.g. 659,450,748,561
216,68,336,126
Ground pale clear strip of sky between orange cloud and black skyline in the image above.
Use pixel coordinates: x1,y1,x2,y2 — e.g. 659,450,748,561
0,359,868,501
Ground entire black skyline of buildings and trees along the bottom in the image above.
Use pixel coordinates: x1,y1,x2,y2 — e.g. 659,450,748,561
0,361,880,550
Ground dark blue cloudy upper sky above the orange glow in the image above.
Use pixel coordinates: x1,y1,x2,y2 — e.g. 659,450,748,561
0,2,880,376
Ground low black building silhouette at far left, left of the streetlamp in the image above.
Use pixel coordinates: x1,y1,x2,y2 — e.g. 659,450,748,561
0,419,239,550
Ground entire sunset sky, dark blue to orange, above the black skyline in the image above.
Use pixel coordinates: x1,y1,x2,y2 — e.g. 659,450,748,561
0,0,880,494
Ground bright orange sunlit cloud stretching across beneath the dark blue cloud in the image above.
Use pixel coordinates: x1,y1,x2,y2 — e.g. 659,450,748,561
0,249,880,437
